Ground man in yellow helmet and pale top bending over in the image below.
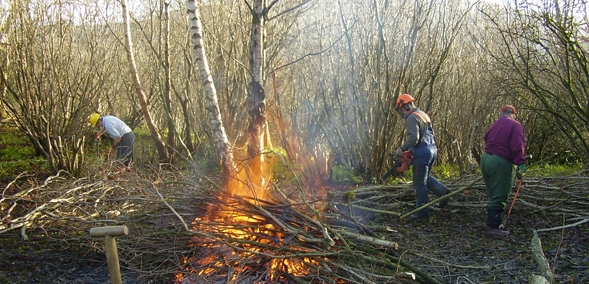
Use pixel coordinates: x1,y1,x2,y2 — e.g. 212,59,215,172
90,113,135,169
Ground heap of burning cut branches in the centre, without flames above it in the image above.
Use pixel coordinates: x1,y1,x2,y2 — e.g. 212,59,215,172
181,193,439,283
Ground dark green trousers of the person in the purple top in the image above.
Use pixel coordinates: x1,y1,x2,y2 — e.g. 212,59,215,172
481,153,515,211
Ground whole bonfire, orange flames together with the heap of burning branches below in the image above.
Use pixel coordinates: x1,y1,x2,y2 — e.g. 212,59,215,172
176,153,435,284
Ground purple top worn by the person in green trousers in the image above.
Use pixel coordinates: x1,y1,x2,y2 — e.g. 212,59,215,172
485,116,526,165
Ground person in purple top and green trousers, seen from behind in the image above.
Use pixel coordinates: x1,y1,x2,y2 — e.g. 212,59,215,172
481,105,526,236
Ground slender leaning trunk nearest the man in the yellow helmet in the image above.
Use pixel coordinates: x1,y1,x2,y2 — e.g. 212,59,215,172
121,0,169,162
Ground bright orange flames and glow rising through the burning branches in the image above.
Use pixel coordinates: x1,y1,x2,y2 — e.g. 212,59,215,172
176,150,330,284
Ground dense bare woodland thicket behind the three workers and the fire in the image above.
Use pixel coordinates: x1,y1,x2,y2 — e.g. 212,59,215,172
0,0,589,184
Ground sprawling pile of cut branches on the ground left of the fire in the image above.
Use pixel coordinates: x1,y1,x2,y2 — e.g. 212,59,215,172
0,171,214,283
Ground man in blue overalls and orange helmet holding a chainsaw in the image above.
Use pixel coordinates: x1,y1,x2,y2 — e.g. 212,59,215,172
395,94,450,220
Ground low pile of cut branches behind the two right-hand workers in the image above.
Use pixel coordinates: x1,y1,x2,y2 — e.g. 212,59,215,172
335,170,589,232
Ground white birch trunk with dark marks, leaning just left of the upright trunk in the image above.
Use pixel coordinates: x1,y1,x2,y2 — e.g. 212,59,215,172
186,0,235,174
